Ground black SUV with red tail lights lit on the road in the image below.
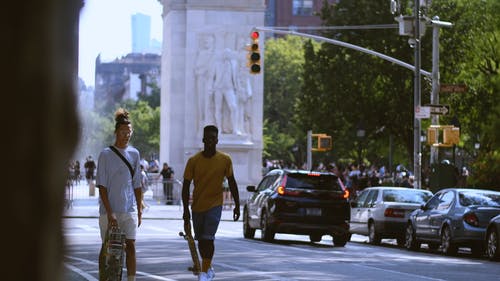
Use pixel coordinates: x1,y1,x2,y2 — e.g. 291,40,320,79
243,169,351,247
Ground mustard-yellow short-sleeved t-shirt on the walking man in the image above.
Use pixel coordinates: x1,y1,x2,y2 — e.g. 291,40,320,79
184,151,233,212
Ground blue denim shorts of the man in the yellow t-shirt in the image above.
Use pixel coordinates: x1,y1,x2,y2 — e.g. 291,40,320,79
193,206,222,240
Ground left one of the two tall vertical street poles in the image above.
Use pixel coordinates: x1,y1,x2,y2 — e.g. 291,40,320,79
413,0,422,189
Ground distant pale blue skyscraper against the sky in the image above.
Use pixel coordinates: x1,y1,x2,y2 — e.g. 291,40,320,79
132,13,151,53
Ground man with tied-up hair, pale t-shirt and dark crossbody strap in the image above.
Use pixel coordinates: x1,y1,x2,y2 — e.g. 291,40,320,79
96,108,142,281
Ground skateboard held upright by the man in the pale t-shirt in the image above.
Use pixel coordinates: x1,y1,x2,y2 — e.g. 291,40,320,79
99,227,125,281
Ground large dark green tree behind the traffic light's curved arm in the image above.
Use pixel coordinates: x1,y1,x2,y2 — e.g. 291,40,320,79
295,0,414,166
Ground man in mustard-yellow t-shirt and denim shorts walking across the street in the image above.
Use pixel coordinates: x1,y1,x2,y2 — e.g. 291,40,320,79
182,125,240,281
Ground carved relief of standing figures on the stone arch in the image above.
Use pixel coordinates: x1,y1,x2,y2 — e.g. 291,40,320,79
194,34,252,136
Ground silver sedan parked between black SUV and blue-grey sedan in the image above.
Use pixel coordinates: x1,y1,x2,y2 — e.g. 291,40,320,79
349,186,432,246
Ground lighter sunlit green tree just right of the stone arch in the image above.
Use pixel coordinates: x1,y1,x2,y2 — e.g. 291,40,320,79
263,36,318,163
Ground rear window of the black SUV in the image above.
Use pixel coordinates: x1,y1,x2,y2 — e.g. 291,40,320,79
286,173,342,191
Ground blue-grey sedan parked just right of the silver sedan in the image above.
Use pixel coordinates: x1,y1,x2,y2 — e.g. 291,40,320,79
405,188,500,256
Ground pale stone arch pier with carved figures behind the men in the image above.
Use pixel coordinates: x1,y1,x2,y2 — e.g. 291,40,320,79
160,0,265,199
